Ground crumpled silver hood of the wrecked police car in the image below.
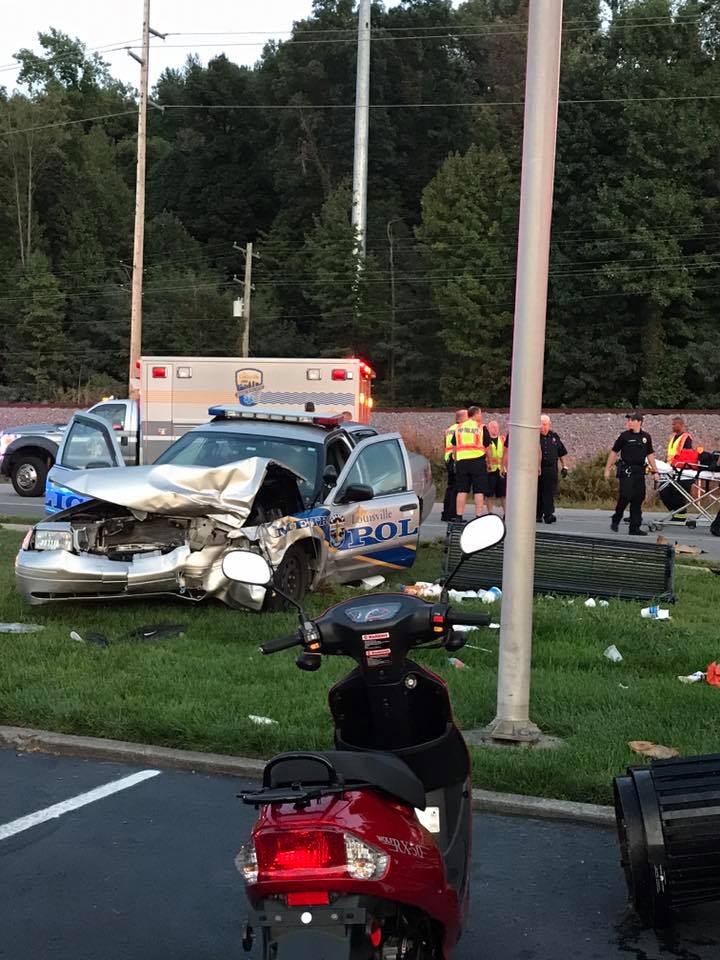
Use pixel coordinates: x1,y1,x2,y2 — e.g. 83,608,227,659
59,457,304,523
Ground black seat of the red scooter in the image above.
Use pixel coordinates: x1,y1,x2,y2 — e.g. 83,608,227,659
263,750,425,810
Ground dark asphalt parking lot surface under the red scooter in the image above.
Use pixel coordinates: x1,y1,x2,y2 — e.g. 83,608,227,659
0,751,720,960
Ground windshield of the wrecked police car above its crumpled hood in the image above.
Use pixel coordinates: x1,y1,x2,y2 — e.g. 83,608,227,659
155,430,323,500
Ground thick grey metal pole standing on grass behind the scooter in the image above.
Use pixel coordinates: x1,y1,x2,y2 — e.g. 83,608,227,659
486,0,563,743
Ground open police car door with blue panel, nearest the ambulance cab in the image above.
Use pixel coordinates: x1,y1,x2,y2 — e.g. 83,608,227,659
45,413,123,514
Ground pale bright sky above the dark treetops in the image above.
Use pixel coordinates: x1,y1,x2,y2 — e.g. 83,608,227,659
0,0,348,89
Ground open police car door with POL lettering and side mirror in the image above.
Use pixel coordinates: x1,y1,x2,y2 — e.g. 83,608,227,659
325,433,420,582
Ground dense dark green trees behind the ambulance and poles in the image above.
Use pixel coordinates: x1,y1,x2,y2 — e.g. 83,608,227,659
0,0,720,407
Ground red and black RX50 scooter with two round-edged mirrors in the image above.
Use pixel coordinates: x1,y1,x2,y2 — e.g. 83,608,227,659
223,515,505,960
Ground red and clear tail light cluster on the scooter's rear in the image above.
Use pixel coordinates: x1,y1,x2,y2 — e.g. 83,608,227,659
252,830,389,883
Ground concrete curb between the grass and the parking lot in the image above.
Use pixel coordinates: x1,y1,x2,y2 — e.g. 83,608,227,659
0,726,615,827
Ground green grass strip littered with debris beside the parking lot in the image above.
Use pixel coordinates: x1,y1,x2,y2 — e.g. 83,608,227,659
0,531,720,802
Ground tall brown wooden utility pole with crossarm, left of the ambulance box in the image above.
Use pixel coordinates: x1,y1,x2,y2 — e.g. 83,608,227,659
128,0,167,400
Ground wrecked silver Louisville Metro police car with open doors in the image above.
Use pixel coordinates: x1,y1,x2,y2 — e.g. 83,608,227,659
15,406,435,610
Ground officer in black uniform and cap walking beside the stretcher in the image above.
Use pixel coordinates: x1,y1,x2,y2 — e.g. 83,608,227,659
605,413,659,537
